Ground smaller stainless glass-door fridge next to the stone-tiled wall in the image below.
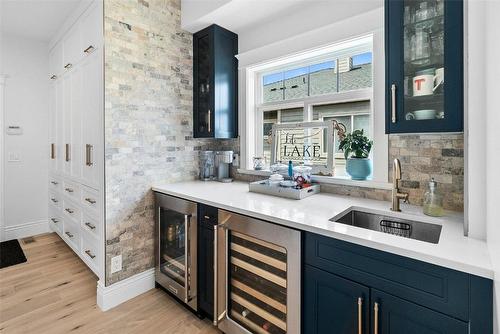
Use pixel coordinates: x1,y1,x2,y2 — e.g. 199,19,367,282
155,193,198,311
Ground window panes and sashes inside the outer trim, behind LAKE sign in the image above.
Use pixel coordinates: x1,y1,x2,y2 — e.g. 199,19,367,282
255,42,372,176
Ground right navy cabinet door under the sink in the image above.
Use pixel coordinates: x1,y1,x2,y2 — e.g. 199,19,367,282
371,289,468,334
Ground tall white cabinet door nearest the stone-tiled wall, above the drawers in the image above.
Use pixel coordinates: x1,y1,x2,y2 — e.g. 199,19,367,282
81,49,104,189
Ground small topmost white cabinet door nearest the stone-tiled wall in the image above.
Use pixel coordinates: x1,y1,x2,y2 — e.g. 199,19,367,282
80,1,104,55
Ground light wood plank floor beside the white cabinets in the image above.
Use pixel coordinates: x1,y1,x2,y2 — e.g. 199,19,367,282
0,233,220,334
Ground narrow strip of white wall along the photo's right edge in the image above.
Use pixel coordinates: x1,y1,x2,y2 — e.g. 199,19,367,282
485,1,500,334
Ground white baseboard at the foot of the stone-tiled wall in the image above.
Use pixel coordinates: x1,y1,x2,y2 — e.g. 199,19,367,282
97,268,155,311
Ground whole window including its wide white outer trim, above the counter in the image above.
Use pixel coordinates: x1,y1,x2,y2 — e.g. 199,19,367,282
240,32,388,183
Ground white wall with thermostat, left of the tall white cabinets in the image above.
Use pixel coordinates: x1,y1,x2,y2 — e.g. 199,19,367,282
0,35,49,240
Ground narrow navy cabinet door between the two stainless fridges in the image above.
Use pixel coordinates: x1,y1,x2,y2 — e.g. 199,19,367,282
198,221,214,319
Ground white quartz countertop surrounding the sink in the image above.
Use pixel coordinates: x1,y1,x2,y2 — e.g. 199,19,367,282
153,181,493,279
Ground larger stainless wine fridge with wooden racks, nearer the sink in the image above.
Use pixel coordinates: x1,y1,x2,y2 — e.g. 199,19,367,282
214,210,301,334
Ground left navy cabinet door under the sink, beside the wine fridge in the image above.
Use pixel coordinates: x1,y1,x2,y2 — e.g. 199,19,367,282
302,265,370,334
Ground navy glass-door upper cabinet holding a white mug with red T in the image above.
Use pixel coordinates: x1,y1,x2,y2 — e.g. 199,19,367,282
385,0,464,133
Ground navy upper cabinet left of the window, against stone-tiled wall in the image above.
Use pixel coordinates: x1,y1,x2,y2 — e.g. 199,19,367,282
193,24,238,138
